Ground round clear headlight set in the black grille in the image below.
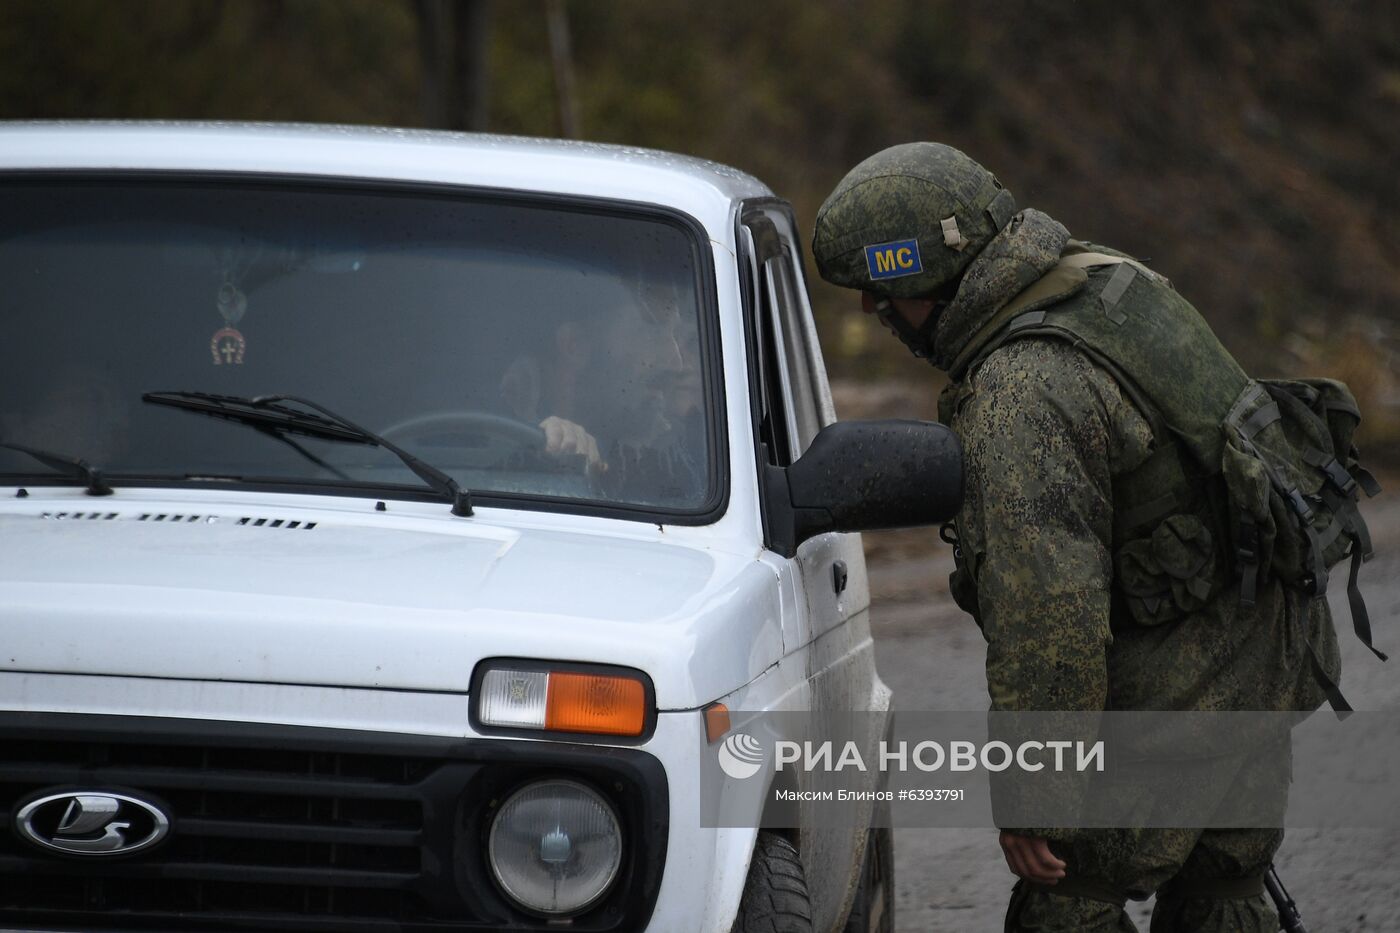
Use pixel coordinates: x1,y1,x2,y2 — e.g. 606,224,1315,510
487,780,622,915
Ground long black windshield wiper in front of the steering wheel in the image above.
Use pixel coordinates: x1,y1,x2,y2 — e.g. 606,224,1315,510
141,392,472,517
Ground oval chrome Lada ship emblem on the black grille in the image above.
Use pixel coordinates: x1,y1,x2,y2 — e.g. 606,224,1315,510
13,790,171,856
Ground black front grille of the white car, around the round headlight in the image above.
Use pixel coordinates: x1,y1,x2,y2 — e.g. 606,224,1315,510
0,713,664,932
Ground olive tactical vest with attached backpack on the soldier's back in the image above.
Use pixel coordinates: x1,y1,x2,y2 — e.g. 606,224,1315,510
941,241,1386,710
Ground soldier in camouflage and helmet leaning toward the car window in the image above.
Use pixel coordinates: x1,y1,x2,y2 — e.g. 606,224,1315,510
812,143,1340,933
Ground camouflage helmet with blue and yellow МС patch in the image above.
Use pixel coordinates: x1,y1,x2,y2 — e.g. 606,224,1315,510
812,143,1016,298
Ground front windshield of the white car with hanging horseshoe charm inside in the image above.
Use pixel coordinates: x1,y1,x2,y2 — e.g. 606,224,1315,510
0,178,718,514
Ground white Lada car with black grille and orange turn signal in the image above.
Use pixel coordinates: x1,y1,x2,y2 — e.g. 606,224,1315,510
0,123,960,933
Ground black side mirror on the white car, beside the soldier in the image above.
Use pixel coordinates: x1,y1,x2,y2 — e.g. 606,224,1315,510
766,420,963,556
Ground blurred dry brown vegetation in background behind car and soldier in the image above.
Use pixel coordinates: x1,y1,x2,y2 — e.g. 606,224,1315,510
0,0,1400,458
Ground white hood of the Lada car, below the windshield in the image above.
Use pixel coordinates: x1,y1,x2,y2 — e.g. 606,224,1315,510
0,500,783,709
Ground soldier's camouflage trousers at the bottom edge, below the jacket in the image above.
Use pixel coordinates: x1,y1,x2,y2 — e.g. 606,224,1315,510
1005,829,1284,933
